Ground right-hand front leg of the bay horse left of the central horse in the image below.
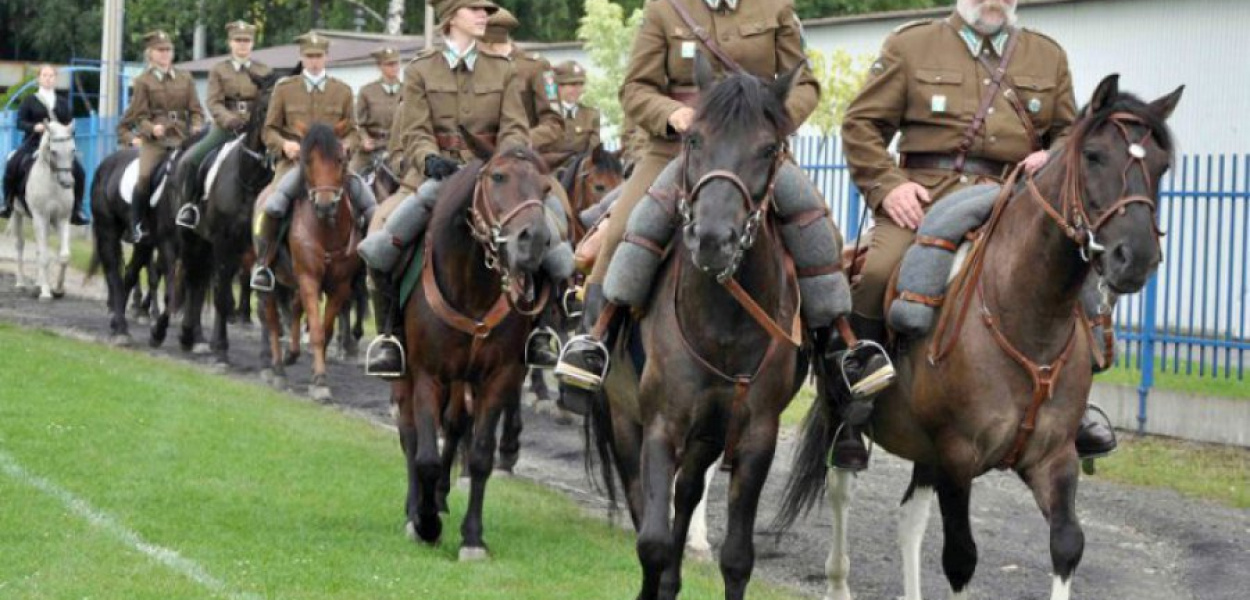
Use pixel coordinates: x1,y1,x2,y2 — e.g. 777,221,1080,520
460,366,512,561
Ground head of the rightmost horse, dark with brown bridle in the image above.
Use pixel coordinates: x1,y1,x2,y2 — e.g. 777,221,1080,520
1060,75,1185,294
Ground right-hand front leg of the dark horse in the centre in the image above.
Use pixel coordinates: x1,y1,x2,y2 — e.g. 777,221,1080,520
720,415,779,600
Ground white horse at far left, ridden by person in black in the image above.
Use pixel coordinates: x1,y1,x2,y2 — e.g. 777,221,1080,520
13,121,75,303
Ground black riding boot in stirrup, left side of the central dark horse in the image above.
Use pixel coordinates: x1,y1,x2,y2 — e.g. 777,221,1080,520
555,284,615,415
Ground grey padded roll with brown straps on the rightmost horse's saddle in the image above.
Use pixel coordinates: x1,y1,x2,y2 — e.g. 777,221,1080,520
889,184,1000,338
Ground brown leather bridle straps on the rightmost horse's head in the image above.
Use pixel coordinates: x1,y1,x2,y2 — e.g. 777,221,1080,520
1026,113,1164,263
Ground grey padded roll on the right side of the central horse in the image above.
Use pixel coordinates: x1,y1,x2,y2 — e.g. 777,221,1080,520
774,161,851,328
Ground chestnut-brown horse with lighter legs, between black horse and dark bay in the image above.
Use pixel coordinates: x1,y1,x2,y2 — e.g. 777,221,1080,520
254,123,361,401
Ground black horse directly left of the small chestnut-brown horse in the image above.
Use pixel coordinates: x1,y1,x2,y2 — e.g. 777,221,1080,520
173,73,280,364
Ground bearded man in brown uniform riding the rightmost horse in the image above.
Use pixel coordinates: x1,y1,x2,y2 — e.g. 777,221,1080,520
834,0,1115,463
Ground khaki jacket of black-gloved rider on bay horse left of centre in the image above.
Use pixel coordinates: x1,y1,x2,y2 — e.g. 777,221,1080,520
391,49,530,189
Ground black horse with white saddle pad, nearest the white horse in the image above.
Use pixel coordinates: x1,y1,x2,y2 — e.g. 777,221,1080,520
88,130,197,346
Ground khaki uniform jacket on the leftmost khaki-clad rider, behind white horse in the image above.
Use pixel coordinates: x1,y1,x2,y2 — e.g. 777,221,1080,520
118,69,204,148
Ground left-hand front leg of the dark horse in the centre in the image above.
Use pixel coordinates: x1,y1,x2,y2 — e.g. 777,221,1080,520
636,416,678,600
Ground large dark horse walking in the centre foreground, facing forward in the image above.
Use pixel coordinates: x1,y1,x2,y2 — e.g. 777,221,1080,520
588,60,808,600
